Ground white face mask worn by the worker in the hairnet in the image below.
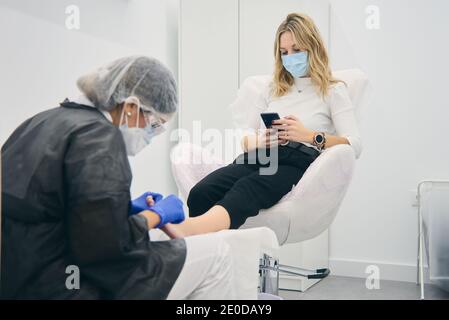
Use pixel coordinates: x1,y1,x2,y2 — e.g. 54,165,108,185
119,98,165,156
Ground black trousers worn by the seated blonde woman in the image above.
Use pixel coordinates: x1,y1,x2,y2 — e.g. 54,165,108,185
187,146,316,229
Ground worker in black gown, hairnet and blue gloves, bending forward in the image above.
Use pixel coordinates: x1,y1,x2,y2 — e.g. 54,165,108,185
1,56,234,299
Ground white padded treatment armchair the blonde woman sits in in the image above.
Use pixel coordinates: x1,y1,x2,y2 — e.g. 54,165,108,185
171,69,368,294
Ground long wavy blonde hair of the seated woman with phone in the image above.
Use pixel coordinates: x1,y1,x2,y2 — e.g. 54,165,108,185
273,13,343,98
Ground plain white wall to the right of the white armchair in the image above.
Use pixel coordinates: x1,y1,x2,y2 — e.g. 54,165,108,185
330,0,449,281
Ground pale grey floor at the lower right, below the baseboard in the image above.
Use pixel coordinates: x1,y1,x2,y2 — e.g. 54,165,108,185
279,276,449,300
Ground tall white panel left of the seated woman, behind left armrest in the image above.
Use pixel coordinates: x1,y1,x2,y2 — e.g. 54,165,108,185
179,0,238,136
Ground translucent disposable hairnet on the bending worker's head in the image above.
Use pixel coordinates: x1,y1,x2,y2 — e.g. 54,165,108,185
77,56,178,115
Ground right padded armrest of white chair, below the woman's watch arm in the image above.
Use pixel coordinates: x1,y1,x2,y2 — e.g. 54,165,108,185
241,145,355,244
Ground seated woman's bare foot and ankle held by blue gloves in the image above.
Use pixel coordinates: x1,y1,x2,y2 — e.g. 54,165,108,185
162,205,231,239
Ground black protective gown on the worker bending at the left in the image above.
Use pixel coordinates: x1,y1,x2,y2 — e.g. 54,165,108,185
1,102,186,299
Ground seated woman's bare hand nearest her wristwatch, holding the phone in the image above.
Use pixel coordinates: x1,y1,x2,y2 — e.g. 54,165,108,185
273,115,314,143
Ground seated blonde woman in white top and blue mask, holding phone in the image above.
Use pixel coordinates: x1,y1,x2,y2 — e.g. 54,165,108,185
164,13,362,237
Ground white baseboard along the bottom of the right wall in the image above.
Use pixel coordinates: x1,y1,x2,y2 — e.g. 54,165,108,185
329,258,429,283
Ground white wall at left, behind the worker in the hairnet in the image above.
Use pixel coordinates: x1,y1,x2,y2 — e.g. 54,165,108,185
0,0,178,195
